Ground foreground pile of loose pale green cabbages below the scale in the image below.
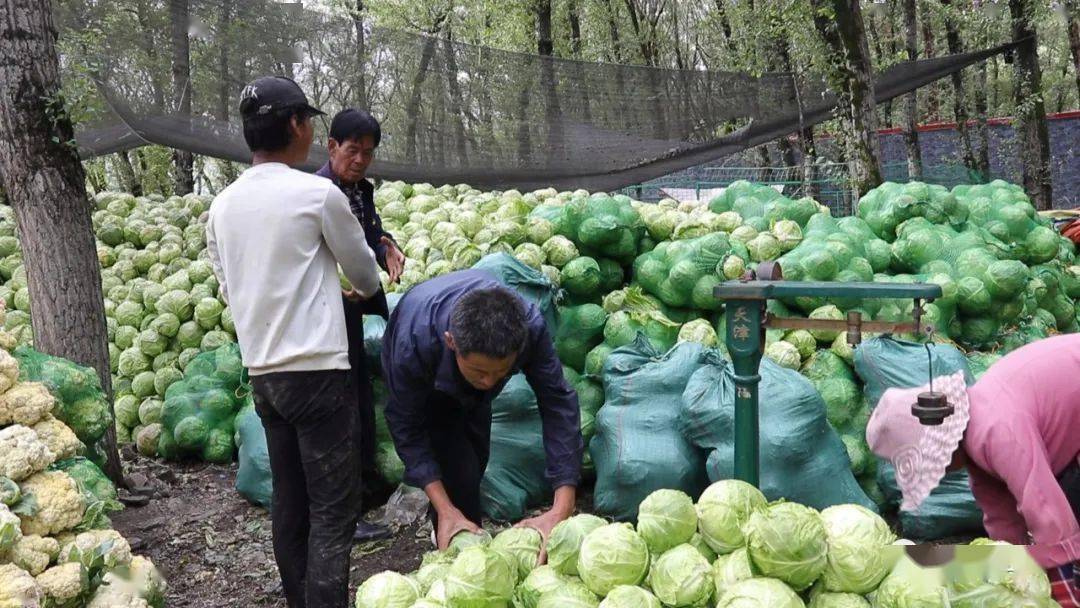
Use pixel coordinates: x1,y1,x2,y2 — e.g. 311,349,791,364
355,481,1053,608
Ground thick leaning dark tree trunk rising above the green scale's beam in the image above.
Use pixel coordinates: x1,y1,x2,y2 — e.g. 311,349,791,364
812,0,881,197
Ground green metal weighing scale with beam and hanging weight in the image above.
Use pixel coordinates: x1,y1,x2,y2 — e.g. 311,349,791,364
713,262,953,487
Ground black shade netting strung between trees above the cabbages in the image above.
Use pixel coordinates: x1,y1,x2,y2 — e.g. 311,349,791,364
58,0,1008,190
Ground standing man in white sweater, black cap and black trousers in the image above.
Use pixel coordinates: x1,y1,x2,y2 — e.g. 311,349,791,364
206,78,379,608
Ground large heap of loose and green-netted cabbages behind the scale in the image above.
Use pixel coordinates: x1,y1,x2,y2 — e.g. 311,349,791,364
367,181,1080,500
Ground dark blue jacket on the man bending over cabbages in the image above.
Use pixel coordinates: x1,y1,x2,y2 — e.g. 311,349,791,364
382,270,584,488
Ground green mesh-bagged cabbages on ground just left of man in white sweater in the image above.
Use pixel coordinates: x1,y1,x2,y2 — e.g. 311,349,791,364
158,343,252,463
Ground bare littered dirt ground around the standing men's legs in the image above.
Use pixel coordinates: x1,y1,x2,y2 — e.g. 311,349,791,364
111,451,430,608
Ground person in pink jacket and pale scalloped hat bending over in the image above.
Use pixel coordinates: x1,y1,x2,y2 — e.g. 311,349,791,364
866,334,1080,606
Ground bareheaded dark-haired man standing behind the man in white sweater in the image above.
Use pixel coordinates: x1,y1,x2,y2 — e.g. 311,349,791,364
315,108,405,542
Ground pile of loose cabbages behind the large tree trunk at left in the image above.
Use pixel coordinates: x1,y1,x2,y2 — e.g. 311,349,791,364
0,197,235,460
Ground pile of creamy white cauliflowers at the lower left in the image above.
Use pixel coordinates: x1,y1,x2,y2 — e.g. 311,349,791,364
0,302,165,608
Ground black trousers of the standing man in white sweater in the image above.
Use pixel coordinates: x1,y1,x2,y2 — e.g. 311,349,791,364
252,370,361,608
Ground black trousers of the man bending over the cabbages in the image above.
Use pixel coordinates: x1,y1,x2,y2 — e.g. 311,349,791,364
428,392,491,529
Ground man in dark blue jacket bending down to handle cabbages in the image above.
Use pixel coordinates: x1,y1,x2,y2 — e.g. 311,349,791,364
382,270,583,549
